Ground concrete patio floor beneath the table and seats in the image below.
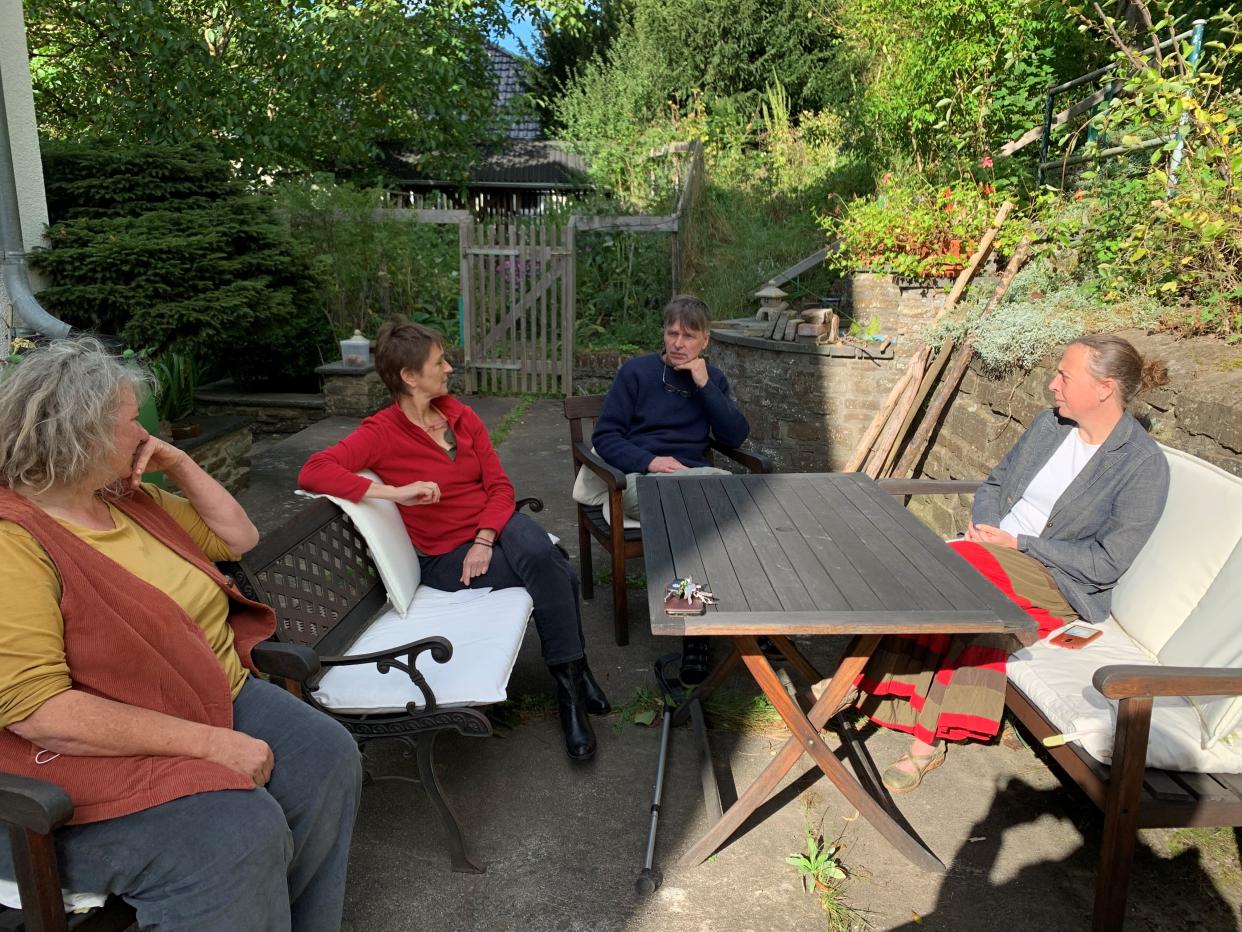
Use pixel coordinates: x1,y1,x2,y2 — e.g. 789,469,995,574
241,398,1242,932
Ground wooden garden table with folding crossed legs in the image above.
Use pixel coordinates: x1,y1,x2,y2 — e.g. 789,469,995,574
638,472,1036,871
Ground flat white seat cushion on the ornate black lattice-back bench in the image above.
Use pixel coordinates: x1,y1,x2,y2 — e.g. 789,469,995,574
315,585,532,713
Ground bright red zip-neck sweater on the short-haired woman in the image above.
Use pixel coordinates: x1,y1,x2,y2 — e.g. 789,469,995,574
298,395,514,555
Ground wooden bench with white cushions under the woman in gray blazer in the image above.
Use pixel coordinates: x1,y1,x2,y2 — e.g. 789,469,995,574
882,447,1242,930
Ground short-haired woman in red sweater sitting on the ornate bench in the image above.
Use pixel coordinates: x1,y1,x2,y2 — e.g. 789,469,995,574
298,321,611,761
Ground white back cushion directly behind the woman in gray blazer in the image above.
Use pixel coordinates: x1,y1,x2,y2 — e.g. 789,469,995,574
1113,447,1242,655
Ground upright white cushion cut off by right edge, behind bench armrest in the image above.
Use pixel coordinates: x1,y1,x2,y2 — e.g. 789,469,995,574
1160,543,1242,748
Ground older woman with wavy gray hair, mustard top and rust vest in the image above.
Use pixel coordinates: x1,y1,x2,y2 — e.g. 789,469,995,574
0,338,361,931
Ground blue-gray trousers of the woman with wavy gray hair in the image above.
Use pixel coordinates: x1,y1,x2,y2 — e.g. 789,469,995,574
0,677,361,932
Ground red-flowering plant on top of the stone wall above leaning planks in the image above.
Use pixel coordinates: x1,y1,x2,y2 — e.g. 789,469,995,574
821,175,1001,281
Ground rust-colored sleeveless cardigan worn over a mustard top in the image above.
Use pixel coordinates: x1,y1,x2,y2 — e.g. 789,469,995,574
0,487,276,824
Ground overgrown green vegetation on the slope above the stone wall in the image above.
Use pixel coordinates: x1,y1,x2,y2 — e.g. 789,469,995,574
544,0,1242,368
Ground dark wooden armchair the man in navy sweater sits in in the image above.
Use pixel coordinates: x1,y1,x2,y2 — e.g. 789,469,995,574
564,395,773,646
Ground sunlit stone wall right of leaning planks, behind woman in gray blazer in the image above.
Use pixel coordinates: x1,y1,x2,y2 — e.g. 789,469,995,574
910,331,1242,536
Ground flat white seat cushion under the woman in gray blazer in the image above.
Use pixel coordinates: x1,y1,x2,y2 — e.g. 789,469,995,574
1007,619,1242,773
